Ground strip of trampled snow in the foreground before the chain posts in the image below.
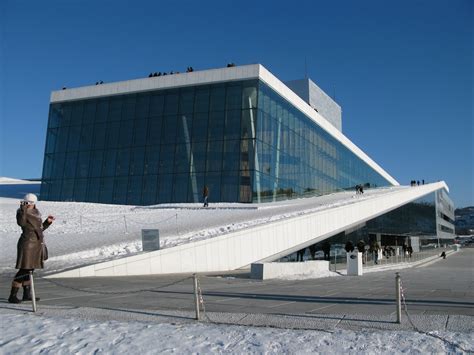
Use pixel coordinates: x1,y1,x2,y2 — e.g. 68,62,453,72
0,311,472,354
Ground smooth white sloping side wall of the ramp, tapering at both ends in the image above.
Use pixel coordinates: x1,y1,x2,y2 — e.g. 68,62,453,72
50,182,448,277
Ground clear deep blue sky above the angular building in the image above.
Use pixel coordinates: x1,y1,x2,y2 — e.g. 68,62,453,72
0,0,474,207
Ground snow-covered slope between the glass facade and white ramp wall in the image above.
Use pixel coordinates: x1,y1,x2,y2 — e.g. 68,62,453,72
0,178,406,273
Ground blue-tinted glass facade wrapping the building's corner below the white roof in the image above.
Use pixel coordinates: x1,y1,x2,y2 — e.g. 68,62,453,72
41,80,390,205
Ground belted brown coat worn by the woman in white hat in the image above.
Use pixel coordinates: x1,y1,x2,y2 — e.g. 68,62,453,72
15,206,51,269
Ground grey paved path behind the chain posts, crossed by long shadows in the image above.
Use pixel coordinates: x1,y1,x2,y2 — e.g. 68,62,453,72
0,249,474,331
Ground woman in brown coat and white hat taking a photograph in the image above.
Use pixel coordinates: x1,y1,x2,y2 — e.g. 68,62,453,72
8,194,54,303
